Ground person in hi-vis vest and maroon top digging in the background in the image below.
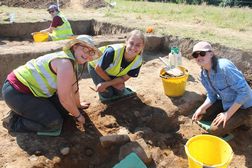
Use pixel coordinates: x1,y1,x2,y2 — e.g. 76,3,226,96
40,5,73,41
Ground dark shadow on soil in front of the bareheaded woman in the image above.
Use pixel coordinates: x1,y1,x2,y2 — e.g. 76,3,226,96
101,97,187,163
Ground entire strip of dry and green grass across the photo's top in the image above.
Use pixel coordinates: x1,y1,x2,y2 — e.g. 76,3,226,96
0,0,252,50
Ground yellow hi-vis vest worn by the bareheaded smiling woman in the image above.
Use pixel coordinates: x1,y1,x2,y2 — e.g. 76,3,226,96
89,44,142,77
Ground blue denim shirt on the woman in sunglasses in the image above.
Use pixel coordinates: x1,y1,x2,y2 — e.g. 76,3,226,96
201,59,252,111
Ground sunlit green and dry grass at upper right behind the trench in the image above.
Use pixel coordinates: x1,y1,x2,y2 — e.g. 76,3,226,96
105,0,252,50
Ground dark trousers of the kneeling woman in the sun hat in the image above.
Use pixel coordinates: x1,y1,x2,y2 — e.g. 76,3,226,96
2,80,68,132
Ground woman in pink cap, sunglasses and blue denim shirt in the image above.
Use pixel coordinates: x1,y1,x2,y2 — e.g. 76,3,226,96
192,41,252,136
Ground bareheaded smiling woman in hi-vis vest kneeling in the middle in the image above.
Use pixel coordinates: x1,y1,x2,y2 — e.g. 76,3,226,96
88,30,145,98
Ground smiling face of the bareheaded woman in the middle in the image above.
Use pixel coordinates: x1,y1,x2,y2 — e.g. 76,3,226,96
125,36,144,58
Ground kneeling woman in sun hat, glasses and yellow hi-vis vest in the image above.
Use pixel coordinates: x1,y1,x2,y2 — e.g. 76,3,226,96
2,35,101,132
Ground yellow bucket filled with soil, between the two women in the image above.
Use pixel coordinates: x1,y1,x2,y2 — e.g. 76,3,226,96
160,66,189,97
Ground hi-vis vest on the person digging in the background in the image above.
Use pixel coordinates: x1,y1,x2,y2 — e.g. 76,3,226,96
50,13,73,41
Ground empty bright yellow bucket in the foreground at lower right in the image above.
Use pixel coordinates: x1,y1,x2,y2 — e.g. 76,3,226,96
185,135,233,168
